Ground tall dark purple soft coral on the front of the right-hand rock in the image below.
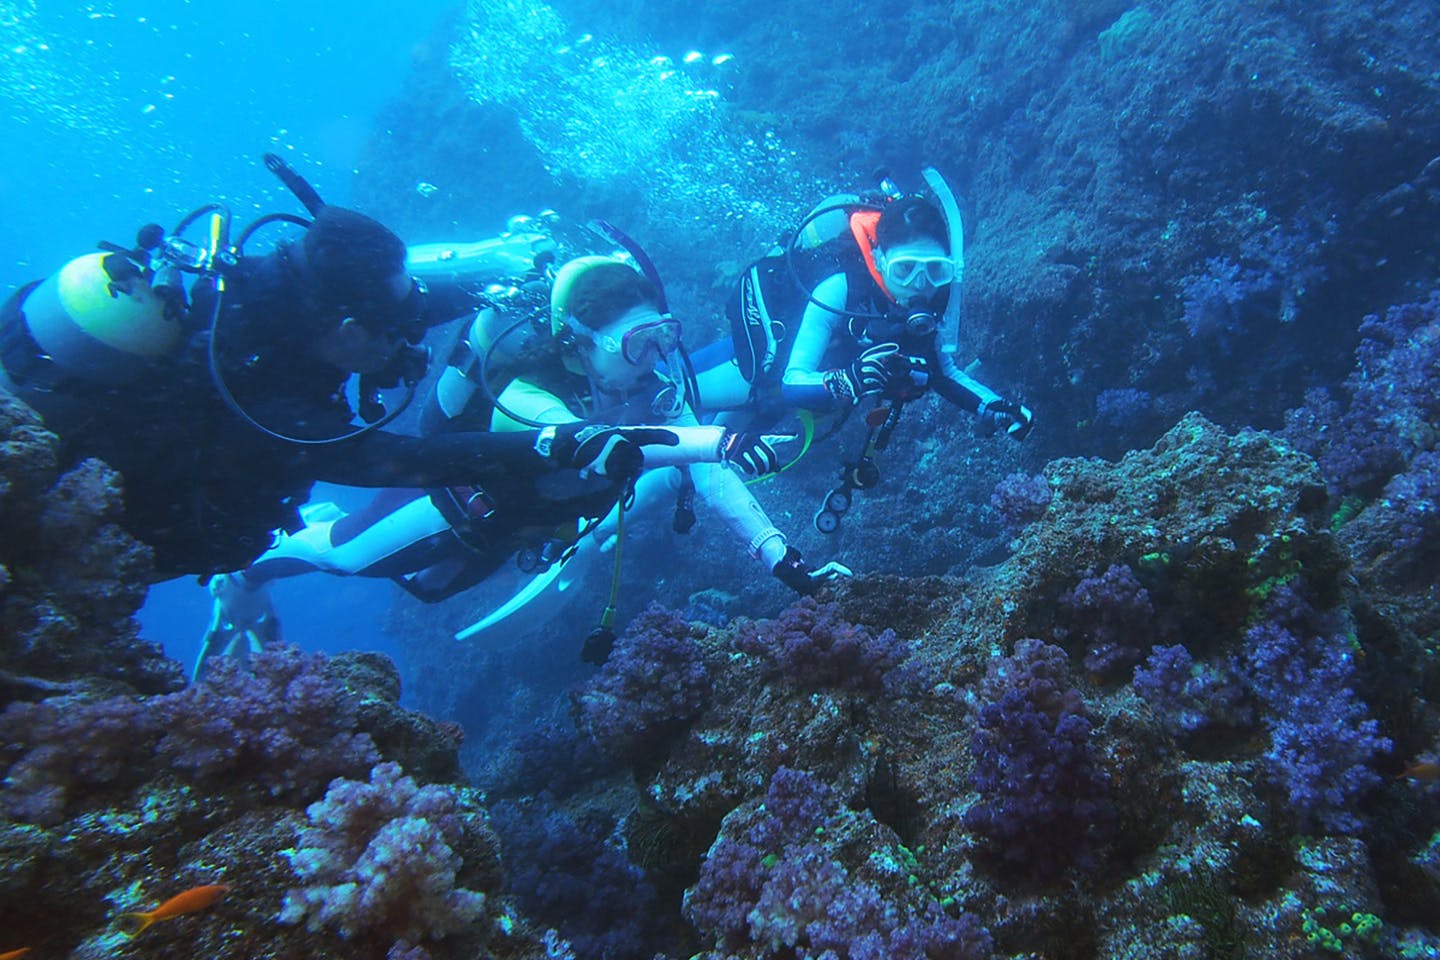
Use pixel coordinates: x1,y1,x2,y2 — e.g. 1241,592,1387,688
965,639,1115,879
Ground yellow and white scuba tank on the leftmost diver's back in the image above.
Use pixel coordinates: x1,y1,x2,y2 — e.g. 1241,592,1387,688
23,253,183,386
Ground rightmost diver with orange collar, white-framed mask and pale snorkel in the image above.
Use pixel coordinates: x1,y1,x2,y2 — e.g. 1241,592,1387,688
696,167,1034,534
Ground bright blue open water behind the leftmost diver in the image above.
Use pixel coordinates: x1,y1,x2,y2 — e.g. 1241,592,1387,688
0,0,455,676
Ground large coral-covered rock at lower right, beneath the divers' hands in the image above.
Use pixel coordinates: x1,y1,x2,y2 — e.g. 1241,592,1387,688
512,415,1440,960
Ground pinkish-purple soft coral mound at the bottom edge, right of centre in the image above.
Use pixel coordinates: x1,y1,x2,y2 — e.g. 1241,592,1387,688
684,767,991,960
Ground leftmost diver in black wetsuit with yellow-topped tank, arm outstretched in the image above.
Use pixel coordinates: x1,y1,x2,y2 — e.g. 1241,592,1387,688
0,155,754,579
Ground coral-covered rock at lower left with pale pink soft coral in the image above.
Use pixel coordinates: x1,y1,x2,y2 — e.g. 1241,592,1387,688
0,648,544,960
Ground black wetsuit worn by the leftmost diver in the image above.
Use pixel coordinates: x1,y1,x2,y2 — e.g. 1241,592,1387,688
0,248,547,577
